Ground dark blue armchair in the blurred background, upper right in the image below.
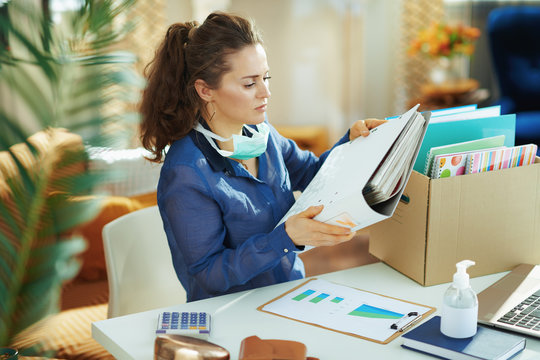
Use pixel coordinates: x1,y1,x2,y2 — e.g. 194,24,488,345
487,6,540,154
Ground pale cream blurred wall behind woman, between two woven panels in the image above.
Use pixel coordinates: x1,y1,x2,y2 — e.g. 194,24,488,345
166,0,422,140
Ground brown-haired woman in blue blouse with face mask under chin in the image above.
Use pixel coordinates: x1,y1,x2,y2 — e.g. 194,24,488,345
141,13,382,301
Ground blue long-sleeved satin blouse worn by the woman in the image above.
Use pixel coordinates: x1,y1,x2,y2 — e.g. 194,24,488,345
157,121,349,301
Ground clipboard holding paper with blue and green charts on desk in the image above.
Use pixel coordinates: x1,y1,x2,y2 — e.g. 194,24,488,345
257,278,436,344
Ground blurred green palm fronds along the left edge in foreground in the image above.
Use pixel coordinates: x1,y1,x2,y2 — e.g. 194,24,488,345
0,0,142,354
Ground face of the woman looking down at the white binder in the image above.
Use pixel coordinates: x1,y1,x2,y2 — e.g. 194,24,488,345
208,44,270,133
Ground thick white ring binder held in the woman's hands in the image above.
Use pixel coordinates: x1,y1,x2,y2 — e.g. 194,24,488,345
278,105,431,231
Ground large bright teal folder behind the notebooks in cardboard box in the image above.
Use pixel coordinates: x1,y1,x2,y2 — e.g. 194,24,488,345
413,114,516,173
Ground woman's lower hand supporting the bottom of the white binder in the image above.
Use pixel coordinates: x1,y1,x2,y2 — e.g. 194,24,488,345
285,205,355,246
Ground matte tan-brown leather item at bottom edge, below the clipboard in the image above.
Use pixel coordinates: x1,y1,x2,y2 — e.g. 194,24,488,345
239,336,318,360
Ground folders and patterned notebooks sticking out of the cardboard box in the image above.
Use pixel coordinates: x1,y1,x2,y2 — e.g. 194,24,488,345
415,105,538,179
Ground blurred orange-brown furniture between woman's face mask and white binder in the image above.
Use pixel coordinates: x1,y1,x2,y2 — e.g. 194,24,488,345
275,125,330,156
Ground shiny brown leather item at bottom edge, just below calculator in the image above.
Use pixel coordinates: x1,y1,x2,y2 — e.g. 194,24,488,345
154,334,230,360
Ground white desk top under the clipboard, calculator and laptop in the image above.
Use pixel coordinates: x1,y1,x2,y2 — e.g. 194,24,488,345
92,263,540,360
